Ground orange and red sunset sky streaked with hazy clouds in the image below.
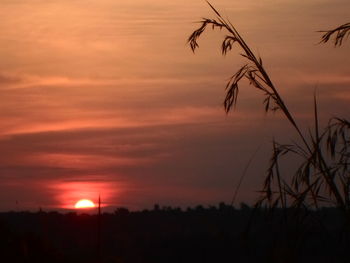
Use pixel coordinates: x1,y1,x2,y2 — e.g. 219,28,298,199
0,0,350,211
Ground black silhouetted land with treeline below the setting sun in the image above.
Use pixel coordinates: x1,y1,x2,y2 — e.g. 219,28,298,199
0,204,350,263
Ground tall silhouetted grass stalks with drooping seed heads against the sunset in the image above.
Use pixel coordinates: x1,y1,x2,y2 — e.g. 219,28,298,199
188,2,350,210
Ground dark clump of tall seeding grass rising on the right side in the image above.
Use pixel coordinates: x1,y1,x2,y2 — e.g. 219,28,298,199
188,2,350,215
